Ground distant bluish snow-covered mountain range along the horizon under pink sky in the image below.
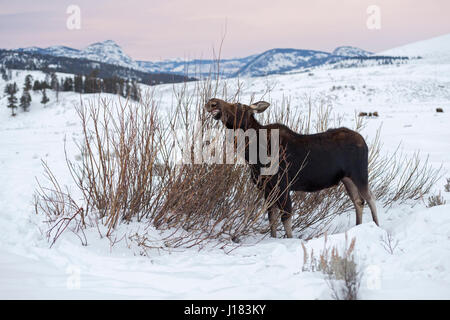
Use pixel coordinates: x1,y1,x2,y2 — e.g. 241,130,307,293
15,40,376,78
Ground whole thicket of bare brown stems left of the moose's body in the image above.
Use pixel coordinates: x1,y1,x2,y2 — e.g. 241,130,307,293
36,82,284,247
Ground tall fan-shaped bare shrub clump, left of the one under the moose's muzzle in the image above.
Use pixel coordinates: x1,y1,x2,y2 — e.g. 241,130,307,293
68,92,170,235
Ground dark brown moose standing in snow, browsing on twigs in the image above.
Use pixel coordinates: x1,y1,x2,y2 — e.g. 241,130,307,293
204,98,379,238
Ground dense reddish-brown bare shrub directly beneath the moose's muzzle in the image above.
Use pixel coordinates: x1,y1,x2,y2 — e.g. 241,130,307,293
150,81,292,247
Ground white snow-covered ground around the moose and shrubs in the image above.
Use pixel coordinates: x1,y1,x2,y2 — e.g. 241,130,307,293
0,35,450,299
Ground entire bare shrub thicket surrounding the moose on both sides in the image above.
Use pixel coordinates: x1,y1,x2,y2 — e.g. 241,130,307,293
36,75,439,247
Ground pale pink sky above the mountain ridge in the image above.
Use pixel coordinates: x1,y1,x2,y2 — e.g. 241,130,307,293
0,0,450,60
